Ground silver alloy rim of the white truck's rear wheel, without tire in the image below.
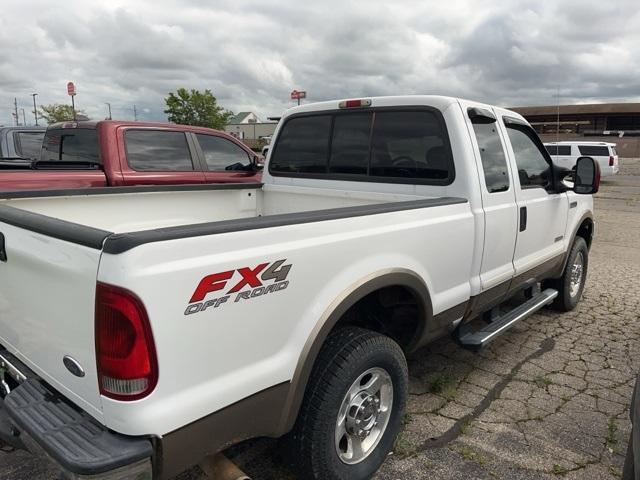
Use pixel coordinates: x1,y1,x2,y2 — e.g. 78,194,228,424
335,367,393,465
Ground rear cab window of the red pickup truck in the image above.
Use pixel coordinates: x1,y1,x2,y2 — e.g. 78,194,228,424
40,128,101,163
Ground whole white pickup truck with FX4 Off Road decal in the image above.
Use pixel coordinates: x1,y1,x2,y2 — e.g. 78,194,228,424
0,96,599,480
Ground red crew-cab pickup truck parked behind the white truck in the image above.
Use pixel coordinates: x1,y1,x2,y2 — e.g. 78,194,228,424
0,120,261,191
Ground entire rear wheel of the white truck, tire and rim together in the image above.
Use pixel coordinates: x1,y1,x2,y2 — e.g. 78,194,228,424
292,327,408,480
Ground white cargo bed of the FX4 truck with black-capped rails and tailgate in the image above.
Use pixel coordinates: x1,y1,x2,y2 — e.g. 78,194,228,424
0,184,475,436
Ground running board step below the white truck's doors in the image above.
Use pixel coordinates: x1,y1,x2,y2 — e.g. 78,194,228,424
459,288,558,349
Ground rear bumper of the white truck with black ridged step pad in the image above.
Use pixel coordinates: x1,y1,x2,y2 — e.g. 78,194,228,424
0,378,153,480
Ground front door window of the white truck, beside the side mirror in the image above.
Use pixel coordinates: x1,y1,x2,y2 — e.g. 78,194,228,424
507,125,551,188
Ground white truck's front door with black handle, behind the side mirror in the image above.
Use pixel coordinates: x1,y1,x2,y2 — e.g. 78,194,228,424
500,116,569,280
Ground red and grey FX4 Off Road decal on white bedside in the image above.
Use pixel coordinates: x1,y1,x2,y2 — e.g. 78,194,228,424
184,259,292,315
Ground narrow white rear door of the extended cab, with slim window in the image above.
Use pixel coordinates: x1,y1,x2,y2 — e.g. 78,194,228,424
460,101,518,295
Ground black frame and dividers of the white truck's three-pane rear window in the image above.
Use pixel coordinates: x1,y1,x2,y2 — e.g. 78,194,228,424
269,105,456,186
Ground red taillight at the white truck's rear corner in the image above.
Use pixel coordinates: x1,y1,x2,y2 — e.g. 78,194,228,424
95,282,158,400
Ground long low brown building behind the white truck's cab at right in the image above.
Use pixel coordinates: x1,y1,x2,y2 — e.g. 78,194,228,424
511,103,640,157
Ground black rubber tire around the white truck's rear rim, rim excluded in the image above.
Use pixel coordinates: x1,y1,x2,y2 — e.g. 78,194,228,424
290,327,408,480
